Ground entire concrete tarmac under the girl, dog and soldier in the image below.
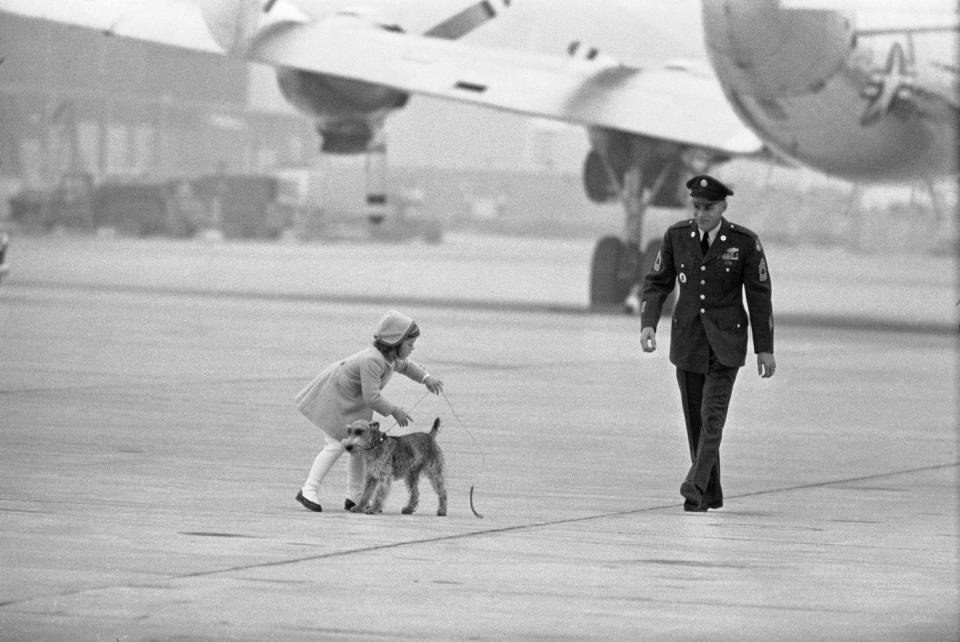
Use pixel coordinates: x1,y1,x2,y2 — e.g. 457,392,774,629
0,234,960,641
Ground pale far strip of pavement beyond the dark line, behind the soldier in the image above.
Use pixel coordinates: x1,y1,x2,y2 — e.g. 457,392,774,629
1,234,960,333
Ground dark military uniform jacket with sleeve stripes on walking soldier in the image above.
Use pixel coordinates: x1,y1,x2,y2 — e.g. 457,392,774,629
640,219,773,373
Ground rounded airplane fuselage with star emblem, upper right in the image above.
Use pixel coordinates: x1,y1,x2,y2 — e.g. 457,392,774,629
703,0,960,181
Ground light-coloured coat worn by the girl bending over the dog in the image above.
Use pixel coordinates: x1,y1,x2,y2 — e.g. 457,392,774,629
296,346,427,439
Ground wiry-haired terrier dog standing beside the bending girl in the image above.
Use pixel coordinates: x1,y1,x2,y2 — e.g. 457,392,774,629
340,417,447,517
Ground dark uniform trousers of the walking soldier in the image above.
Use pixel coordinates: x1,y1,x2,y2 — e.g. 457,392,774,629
677,350,740,502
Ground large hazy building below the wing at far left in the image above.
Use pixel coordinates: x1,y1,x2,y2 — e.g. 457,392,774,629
0,15,316,185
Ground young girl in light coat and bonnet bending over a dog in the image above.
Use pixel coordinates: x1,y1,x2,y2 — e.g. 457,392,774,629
296,310,443,512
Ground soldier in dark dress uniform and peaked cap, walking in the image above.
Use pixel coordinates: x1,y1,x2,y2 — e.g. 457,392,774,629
640,175,777,511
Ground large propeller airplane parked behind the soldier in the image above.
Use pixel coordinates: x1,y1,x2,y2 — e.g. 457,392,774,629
0,0,960,307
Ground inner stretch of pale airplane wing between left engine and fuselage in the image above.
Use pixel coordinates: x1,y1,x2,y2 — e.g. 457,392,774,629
249,23,762,155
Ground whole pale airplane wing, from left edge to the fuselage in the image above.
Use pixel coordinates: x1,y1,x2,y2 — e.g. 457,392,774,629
0,0,763,155
